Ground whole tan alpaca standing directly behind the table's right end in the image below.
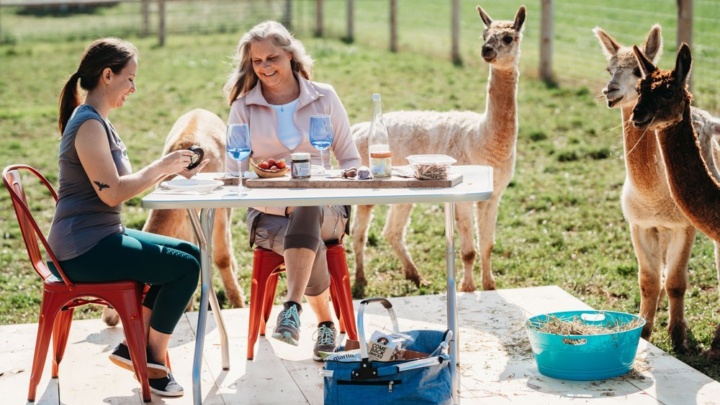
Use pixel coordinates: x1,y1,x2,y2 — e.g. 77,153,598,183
352,6,526,291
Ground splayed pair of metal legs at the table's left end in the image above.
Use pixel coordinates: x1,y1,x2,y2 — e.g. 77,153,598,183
187,208,230,405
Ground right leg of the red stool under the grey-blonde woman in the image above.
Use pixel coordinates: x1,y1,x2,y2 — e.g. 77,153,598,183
327,245,358,340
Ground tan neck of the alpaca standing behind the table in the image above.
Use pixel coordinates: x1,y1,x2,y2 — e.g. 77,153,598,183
485,66,520,156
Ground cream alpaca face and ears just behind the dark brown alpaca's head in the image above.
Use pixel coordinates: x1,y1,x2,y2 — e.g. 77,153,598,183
593,24,662,108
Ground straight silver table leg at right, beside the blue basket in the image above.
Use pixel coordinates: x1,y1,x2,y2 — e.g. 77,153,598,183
445,202,460,404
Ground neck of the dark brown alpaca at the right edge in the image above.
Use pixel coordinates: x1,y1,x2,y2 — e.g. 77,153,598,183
657,102,720,242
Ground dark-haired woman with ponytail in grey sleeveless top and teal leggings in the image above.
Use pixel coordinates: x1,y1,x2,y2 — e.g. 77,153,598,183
48,38,208,396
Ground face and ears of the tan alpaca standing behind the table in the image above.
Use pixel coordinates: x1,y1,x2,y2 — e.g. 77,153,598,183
477,6,526,69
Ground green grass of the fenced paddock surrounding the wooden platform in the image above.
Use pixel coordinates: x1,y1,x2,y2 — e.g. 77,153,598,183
0,1,720,379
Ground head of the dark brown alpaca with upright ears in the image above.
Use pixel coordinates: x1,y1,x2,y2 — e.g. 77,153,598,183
632,44,692,130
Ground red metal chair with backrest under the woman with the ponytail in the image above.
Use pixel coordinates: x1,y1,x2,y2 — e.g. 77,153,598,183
2,165,151,402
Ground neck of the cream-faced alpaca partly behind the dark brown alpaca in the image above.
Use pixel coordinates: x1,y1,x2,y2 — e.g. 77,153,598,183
621,106,666,193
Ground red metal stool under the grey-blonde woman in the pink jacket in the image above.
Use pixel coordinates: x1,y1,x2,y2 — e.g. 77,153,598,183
247,243,357,360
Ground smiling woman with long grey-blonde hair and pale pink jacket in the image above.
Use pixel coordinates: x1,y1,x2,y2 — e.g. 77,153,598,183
224,21,360,361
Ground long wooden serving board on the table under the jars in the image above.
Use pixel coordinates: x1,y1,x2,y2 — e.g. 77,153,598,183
243,173,462,188
